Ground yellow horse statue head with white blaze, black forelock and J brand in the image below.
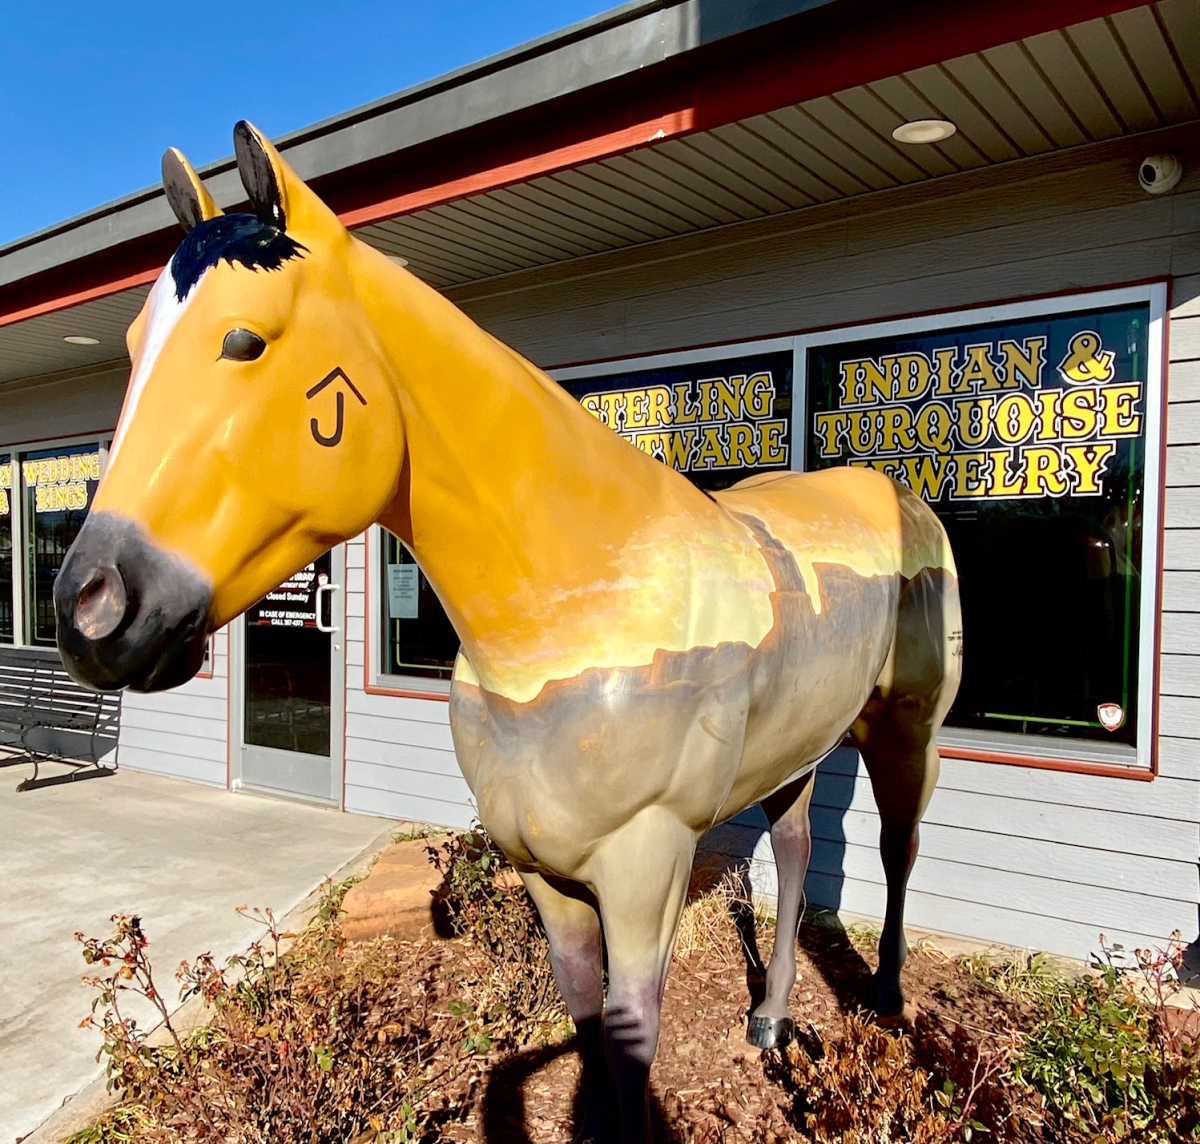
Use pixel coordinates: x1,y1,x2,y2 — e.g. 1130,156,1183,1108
54,122,414,690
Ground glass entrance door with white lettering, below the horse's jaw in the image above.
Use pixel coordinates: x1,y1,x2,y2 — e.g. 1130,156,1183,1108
240,547,346,802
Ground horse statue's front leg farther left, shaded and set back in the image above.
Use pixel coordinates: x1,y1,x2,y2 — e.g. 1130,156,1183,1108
521,873,616,1144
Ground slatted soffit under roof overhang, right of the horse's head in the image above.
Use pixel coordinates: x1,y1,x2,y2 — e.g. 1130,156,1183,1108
358,0,1200,287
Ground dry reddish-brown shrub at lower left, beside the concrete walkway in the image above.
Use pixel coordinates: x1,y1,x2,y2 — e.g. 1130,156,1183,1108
73,883,481,1144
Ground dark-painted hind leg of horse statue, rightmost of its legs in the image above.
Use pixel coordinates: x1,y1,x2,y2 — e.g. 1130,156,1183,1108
851,570,962,1017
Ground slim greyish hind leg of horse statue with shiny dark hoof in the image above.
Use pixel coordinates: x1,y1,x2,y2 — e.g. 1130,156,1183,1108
746,772,812,1049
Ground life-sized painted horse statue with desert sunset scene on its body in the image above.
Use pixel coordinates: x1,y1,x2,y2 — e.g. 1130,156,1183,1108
54,122,961,1144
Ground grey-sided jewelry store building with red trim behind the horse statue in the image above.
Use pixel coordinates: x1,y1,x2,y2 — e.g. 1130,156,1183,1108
0,0,1200,956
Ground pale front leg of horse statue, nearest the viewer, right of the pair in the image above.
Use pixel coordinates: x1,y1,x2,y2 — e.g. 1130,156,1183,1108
588,807,696,1144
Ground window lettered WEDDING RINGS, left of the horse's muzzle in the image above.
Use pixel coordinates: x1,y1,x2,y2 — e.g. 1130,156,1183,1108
19,443,100,646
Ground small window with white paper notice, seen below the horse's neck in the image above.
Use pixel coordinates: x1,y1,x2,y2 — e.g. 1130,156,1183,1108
380,532,458,679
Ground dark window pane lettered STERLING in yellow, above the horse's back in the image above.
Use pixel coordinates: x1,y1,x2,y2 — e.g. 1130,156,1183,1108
559,349,793,490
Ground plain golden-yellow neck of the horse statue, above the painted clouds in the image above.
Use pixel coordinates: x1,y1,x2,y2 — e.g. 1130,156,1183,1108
360,252,719,677
